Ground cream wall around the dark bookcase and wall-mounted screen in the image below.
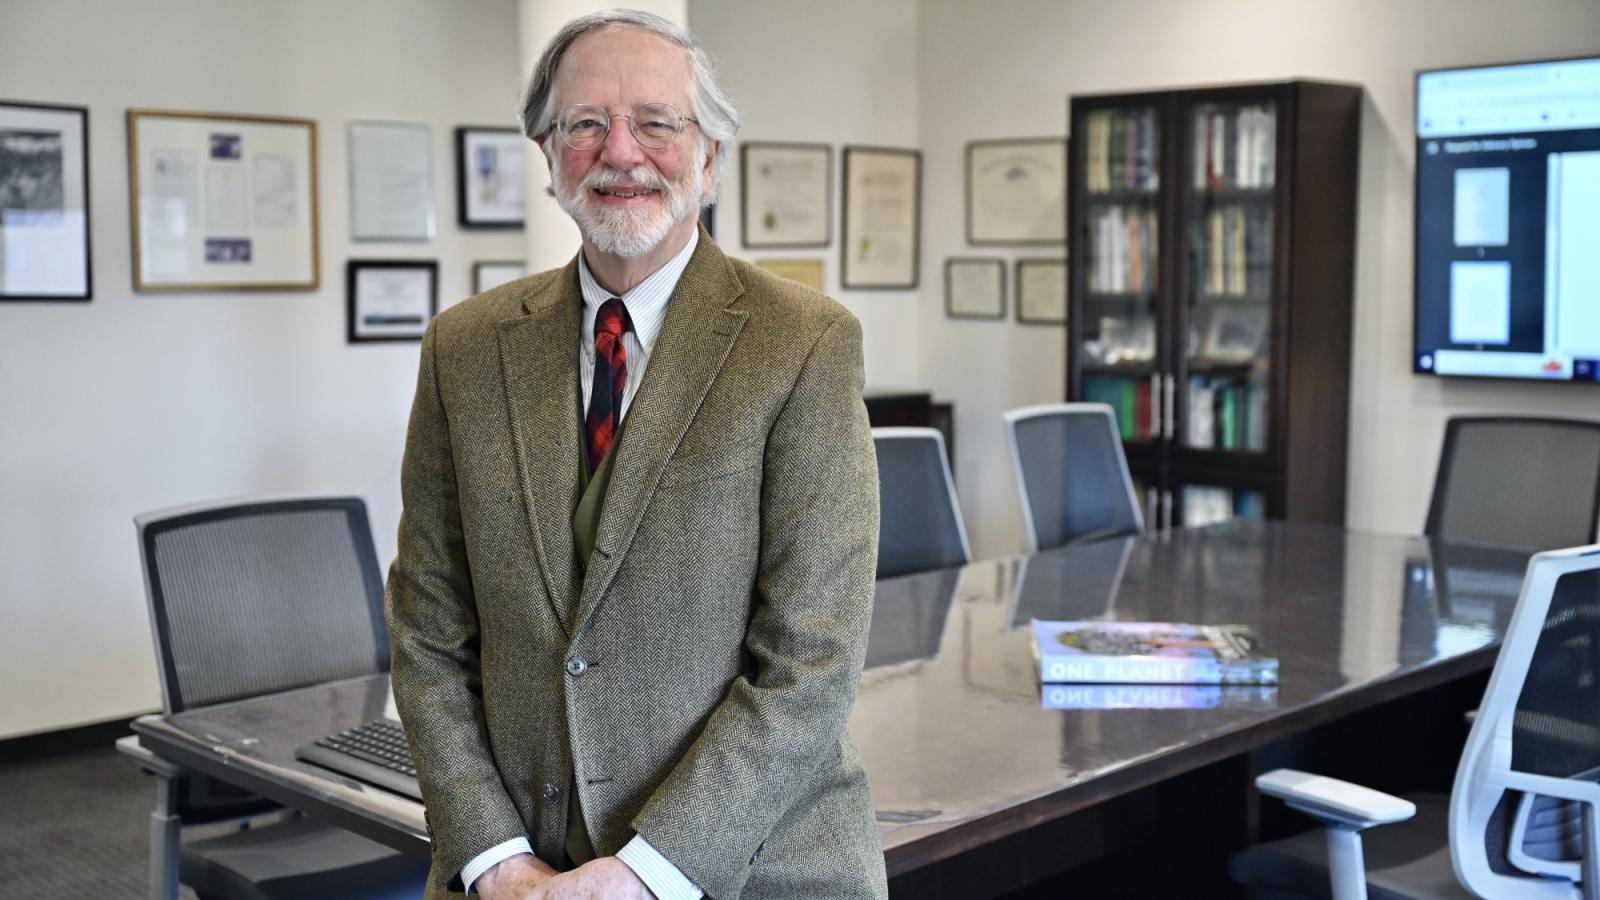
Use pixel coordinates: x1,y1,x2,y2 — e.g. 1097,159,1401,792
918,0,1600,556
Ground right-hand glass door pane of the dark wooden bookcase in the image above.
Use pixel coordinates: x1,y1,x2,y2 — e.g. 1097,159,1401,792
1176,101,1277,454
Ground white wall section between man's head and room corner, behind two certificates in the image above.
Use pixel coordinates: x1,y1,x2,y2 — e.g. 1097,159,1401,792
688,0,930,388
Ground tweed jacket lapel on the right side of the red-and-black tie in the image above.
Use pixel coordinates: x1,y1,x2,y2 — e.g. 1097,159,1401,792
573,231,749,634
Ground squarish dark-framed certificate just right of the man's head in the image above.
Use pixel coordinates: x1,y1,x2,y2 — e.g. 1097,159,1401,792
739,141,834,247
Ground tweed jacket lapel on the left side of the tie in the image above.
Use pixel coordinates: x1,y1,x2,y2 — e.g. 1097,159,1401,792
499,258,582,636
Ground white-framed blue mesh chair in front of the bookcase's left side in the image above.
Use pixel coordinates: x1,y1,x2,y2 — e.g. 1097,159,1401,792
1005,404,1144,552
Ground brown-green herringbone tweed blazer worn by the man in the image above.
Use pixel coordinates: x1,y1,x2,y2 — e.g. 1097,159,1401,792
387,232,886,900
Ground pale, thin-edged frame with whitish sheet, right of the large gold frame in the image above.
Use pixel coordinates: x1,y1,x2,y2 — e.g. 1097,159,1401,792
349,122,434,240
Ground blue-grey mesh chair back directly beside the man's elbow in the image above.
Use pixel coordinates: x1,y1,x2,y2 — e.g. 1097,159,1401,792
872,428,973,578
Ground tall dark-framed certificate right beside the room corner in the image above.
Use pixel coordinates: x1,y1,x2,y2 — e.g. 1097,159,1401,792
840,147,922,288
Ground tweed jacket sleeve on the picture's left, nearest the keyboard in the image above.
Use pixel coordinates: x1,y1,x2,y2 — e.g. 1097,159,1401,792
386,320,526,890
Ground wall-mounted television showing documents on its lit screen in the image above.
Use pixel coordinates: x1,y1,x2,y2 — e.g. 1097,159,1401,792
1411,58,1600,381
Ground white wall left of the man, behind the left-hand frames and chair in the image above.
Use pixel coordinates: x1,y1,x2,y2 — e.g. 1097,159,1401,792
0,0,523,737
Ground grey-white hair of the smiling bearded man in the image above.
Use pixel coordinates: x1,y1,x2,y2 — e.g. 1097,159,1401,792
522,10,739,203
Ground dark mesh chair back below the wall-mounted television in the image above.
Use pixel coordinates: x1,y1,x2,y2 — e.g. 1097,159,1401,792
1424,416,1600,549
